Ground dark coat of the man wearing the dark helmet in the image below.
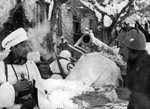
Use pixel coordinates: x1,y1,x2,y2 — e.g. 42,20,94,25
127,51,150,109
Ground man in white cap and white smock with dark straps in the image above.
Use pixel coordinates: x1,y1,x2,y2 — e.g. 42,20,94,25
0,28,40,109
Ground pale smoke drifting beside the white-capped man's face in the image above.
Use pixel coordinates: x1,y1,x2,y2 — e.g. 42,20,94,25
27,21,52,60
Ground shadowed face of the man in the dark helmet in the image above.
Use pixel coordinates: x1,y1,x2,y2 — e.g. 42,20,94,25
119,43,129,62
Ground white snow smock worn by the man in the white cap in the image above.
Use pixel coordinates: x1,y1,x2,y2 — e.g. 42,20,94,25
0,61,41,107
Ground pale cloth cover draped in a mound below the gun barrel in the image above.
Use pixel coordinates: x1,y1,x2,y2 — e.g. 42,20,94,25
66,52,121,86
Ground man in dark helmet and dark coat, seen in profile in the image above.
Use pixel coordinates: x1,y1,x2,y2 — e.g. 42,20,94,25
116,27,150,109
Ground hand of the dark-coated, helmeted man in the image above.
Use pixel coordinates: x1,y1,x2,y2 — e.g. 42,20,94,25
116,88,131,100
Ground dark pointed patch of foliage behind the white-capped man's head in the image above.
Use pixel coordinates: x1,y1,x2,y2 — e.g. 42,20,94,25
0,3,32,49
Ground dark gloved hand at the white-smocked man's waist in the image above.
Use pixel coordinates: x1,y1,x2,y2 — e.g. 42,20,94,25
13,79,32,92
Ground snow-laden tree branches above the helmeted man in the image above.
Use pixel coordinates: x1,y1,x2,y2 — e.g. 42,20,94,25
80,0,149,44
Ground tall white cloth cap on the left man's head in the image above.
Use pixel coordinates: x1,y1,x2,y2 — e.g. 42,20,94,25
2,28,29,50
